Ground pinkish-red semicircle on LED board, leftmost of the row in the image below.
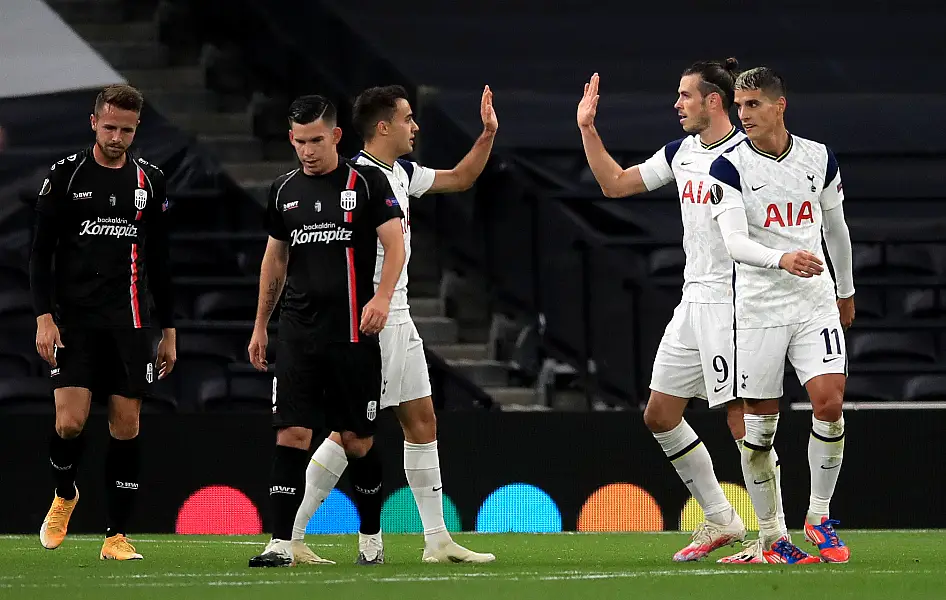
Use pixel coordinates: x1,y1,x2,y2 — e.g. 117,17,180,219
174,485,263,535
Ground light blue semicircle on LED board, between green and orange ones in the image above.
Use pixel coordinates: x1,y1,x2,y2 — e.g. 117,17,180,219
476,483,562,533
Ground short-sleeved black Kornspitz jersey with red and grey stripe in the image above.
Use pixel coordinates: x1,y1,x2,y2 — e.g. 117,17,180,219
266,157,404,344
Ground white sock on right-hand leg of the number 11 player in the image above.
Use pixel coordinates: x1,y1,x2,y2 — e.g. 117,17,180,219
808,415,844,525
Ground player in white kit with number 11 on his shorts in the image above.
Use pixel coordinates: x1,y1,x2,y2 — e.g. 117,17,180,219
710,67,854,564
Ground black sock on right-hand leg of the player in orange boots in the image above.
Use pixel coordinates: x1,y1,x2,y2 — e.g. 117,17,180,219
105,437,141,537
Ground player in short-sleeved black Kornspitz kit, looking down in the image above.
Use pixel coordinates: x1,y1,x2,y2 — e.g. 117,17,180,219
249,96,405,567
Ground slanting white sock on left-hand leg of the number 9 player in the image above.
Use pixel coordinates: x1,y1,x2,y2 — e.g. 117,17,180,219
654,419,735,525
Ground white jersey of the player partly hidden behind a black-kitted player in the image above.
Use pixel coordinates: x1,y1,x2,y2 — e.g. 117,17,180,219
355,150,435,325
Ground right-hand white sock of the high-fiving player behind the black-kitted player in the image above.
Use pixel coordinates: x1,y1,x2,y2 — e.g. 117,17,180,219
404,440,451,548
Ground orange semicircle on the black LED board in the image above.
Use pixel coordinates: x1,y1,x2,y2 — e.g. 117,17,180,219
578,483,664,531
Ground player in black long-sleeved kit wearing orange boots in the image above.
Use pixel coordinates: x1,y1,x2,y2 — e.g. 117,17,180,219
30,85,176,560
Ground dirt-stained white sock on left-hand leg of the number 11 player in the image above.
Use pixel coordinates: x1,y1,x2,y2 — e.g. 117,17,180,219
742,413,788,548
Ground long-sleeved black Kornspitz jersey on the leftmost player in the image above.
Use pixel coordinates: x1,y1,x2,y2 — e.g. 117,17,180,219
30,148,174,329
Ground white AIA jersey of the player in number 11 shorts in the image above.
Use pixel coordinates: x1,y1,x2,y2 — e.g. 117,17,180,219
710,135,844,329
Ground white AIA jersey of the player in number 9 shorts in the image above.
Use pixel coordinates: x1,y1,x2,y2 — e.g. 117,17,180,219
639,127,746,304
